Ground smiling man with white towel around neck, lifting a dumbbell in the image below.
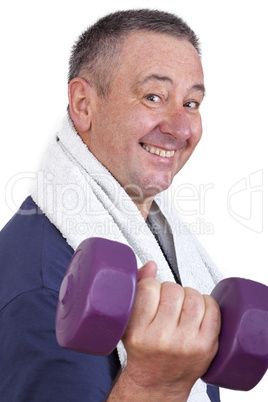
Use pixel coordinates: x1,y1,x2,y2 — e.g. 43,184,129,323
0,10,220,401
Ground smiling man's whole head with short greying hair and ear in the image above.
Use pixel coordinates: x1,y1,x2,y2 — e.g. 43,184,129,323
69,10,204,216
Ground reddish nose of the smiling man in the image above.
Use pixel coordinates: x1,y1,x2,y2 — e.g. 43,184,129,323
159,106,192,141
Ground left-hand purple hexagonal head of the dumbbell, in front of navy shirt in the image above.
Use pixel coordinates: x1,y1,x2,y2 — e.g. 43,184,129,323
56,238,137,355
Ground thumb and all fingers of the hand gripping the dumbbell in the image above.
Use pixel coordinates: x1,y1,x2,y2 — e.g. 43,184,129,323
132,261,220,341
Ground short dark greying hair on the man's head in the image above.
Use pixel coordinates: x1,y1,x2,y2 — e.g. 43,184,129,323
68,9,200,97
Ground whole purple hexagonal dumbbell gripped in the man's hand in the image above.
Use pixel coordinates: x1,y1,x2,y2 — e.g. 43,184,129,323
56,237,268,390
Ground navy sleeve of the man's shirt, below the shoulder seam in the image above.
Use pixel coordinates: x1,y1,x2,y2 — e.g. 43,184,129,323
0,288,120,402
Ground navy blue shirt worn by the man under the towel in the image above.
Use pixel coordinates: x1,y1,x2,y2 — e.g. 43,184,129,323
0,197,219,402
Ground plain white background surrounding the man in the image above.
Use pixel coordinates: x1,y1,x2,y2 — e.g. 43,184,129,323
0,0,268,402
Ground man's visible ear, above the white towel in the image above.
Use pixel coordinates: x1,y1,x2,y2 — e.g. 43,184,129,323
68,77,91,133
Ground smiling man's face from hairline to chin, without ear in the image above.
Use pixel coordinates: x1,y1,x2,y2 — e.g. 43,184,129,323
86,32,204,202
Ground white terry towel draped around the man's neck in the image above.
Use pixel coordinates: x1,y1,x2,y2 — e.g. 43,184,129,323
31,116,221,402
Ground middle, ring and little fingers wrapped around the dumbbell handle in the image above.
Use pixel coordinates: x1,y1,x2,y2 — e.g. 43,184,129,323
153,282,220,362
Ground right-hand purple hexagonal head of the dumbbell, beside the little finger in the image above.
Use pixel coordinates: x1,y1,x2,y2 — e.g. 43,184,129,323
202,278,268,391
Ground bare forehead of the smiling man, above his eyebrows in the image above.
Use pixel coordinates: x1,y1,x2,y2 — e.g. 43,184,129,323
112,32,203,89
